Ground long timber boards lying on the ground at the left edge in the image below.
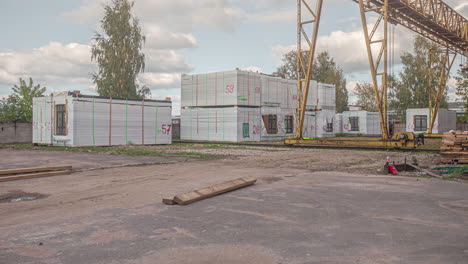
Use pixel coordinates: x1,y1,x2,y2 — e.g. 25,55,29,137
0,166,72,182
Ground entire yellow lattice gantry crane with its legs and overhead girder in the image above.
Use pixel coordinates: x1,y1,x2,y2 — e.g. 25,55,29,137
296,0,468,139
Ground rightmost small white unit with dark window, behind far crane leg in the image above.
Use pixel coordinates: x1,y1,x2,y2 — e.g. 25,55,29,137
406,108,457,134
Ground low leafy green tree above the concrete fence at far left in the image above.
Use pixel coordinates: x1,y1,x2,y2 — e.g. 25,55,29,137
0,78,46,122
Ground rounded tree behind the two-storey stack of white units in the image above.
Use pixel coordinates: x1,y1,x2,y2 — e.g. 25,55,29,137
273,51,348,113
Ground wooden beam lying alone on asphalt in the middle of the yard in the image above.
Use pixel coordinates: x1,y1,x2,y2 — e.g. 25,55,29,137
173,176,257,205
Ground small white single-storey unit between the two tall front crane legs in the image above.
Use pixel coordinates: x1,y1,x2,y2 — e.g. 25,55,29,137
342,111,382,136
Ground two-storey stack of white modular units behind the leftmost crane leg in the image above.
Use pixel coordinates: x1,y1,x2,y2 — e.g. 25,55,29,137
181,70,336,142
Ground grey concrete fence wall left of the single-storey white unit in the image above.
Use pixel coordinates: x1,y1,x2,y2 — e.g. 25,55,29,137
0,122,32,144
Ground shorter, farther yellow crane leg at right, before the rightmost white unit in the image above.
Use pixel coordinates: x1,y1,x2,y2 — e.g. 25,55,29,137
427,45,457,134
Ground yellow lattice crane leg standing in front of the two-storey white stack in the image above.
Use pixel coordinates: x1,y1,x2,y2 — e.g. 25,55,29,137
296,0,323,139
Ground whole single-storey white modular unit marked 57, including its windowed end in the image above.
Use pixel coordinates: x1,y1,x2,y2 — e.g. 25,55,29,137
33,92,172,147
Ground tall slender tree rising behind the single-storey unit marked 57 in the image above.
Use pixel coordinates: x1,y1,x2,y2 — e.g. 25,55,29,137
91,0,150,98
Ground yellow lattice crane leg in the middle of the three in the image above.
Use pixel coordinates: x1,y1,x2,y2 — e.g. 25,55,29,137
359,0,390,139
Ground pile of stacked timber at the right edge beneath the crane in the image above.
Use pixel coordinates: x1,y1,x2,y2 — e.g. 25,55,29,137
440,131,468,163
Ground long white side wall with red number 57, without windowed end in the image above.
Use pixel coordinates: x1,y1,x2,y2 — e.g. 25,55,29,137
73,98,172,146
